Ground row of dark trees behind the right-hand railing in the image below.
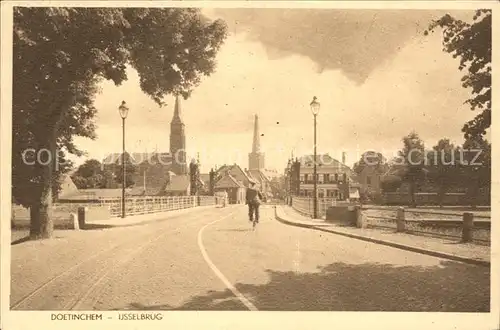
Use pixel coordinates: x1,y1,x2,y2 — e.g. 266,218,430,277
354,132,491,206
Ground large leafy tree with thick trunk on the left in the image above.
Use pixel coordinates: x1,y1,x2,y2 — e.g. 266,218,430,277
12,7,226,238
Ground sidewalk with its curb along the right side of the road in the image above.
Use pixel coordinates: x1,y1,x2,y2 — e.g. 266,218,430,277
276,206,491,267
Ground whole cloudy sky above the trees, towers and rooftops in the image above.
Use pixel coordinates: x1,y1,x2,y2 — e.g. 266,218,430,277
71,9,484,172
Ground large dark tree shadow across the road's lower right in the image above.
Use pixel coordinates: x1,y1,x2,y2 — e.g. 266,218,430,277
119,262,490,312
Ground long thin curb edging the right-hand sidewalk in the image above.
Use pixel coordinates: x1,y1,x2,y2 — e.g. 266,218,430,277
275,209,491,267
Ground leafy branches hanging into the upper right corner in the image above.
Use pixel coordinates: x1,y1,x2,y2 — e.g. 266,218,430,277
425,9,492,139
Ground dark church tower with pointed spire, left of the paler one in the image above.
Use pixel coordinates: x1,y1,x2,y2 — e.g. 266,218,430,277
170,95,187,175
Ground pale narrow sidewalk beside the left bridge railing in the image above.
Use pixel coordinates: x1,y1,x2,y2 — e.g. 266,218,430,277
85,205,218,227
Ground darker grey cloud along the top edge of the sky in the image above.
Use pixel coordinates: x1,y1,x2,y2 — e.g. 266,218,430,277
212,8,472,83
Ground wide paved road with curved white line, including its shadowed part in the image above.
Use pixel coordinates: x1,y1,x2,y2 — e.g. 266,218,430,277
12,206,490,312
